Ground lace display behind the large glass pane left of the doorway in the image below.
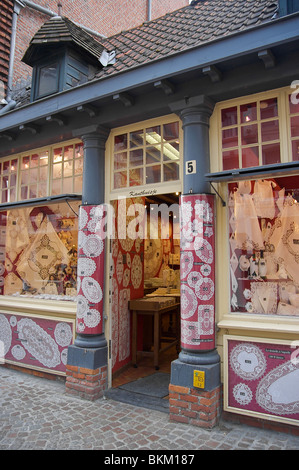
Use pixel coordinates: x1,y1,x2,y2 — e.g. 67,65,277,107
0,201,79,300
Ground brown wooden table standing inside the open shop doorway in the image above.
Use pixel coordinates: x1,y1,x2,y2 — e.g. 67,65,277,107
129,297,180,370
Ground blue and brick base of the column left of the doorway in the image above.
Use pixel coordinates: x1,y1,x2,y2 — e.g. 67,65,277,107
65,345,108,401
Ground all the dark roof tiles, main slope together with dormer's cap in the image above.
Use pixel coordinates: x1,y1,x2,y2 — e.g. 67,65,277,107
17,0,278,106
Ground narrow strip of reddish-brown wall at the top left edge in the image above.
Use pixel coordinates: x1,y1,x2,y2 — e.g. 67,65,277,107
0,0,13,92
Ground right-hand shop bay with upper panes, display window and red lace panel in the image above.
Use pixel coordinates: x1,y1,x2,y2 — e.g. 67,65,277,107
207,87,299,426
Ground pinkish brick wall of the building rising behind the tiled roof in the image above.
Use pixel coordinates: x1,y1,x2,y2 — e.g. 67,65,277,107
12,0,189,83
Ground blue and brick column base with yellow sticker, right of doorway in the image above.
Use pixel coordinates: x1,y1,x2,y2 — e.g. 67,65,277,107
169,352,221,429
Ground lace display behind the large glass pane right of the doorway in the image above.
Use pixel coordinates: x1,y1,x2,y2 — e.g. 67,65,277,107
228,176,299,316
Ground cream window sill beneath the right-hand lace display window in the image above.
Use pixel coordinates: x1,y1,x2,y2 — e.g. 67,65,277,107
217,314,299,335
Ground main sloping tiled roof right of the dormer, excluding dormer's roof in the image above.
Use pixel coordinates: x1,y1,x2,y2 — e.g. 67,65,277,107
97,0,278,78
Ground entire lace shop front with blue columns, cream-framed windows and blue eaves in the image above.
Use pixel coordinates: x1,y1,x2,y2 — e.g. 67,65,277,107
0,1,299,434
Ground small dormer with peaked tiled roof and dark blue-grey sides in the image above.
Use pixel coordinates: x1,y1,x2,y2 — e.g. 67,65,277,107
22,16,114,101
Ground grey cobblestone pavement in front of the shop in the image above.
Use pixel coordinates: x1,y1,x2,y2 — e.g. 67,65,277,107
0,366,299,452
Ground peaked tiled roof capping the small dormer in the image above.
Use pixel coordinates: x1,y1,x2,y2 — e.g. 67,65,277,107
22,16,104,65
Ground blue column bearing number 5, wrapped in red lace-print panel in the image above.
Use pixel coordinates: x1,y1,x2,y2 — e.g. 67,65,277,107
170,95,220,424
